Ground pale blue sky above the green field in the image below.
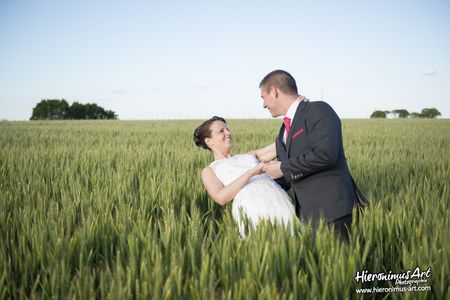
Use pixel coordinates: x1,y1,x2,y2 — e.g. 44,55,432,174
0,0,450,120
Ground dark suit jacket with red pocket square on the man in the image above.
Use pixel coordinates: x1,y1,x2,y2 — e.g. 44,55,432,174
276,101,355,225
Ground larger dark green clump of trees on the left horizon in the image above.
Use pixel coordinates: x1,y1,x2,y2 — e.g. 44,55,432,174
30,99,117,120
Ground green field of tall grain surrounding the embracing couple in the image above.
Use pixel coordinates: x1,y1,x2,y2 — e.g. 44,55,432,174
0,120,450,299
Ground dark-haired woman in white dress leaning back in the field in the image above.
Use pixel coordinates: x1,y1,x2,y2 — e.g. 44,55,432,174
194,116,295,237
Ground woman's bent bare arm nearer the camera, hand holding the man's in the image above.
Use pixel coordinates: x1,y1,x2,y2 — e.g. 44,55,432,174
202,163,266,205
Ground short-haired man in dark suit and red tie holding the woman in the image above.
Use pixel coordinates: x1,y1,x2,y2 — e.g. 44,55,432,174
259,70,356,238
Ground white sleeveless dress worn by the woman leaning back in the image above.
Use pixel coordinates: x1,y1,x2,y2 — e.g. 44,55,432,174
210,154,295,237
